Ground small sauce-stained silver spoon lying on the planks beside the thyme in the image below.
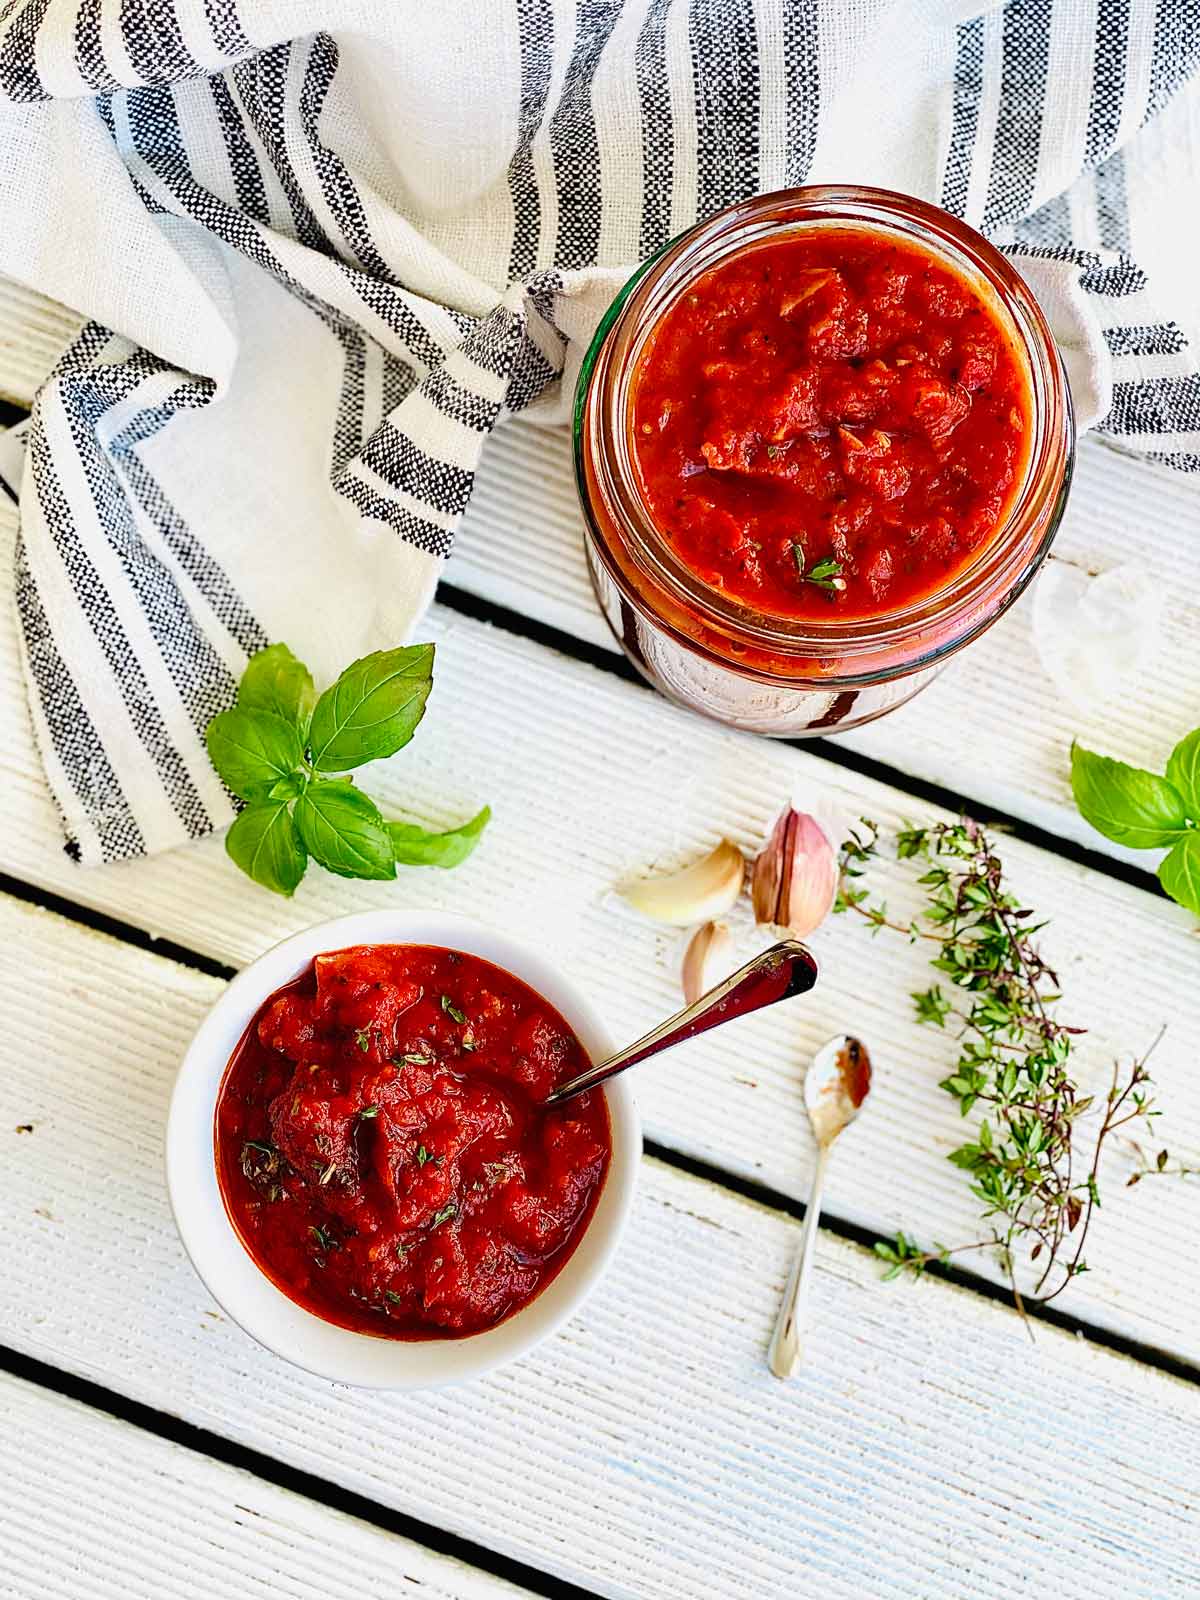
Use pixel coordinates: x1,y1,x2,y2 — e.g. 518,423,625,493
766,1034,870,1378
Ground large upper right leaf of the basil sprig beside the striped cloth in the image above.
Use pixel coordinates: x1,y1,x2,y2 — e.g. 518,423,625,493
309,645,434,773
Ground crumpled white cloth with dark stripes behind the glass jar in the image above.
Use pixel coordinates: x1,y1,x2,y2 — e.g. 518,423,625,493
0,0,1200,862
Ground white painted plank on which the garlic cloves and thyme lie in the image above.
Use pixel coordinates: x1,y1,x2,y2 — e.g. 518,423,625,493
0,489,1200,1362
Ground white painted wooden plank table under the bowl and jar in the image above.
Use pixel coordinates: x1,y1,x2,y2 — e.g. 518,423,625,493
0,285,1200,1600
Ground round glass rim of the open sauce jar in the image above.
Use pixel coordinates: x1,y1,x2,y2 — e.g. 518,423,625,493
574,184,1074,683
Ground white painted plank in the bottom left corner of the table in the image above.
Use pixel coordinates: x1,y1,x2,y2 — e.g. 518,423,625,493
0,1374,526,1600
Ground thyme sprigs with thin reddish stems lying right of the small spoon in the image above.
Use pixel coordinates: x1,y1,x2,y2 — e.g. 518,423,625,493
834,818,1170,1309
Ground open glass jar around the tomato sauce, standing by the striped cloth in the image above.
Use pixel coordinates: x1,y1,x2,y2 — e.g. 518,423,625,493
574,186,1075,738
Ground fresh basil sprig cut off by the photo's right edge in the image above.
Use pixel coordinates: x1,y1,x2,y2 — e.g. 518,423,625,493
1070,728,1200,917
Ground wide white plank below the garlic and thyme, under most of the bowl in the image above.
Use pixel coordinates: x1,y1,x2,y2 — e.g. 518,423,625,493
0,901,1200,1600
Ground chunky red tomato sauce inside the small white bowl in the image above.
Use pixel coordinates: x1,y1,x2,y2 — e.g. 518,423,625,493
214,944,611,1339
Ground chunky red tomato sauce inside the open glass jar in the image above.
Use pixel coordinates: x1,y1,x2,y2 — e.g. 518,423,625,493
630,230,1030,618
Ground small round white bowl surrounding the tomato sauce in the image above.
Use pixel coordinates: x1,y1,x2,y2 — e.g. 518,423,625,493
166,910,642,1389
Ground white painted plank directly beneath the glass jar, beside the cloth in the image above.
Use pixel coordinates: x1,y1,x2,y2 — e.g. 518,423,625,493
446,419,1200,867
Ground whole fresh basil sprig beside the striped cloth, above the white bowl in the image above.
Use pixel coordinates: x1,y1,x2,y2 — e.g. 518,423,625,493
206,645,491,894
